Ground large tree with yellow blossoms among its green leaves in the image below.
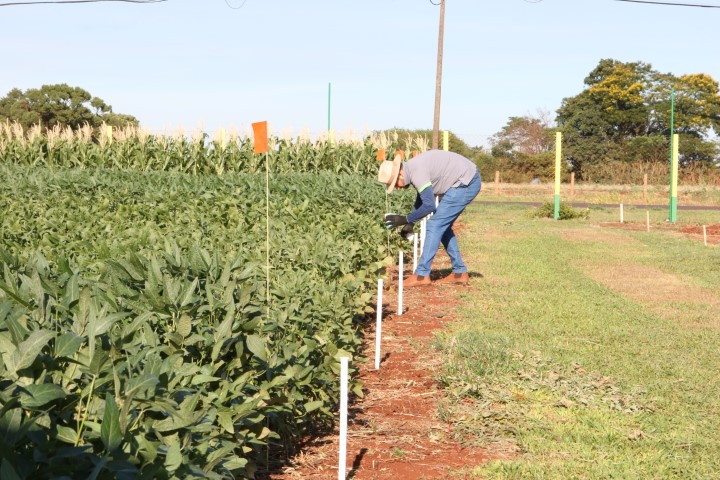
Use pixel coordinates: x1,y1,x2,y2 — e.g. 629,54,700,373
556,59,720,178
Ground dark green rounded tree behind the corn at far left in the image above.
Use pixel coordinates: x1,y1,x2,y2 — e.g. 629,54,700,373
0,83,139,129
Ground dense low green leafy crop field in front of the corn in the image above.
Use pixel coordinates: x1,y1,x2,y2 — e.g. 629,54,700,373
0,160,411,480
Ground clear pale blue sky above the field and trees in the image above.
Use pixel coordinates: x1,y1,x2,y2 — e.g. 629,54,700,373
0,0,720,145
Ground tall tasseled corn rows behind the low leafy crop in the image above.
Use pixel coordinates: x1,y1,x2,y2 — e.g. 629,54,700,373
0,123,428,176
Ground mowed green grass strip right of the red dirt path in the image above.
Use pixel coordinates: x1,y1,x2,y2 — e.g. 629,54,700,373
438,205,720,479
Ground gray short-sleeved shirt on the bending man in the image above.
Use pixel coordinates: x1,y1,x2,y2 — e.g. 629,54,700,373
403,150,477,195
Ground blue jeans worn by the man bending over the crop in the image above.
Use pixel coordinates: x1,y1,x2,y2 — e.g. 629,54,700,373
415,174,482,277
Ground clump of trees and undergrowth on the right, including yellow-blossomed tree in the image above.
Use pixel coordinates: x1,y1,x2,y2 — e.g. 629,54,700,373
485,59,720,183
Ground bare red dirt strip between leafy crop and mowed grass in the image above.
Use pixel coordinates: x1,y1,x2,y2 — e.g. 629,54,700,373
271,252,497,480
